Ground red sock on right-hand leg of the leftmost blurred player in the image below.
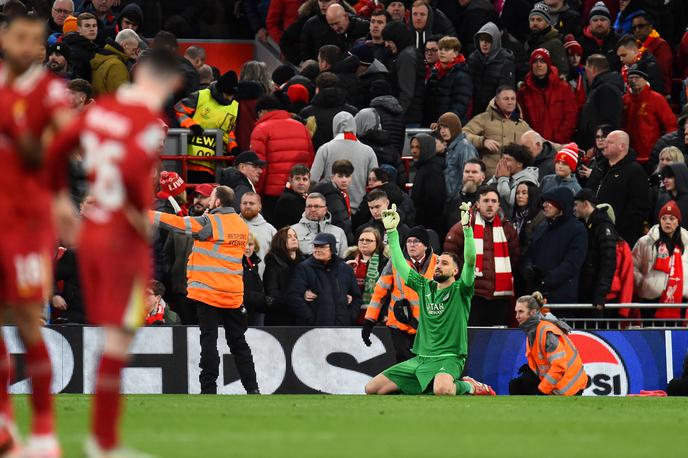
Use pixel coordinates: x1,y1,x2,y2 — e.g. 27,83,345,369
26,340,55,435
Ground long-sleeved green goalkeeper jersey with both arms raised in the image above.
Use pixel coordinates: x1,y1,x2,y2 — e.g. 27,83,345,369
388,228,475,358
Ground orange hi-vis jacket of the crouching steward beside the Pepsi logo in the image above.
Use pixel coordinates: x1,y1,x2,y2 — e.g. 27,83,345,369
526,320,588,396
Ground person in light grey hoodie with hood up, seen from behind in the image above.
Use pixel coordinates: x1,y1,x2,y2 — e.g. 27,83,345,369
310,111,378,213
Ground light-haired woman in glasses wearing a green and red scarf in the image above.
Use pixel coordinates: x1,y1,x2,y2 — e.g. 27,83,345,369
344,227,388,324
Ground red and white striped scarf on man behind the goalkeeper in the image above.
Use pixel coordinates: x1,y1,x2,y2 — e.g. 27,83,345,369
473,212,514,296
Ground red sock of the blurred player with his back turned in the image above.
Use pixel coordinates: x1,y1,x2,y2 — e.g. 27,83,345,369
91,355,124,450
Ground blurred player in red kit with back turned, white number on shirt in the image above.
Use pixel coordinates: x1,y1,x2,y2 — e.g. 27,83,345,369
48,50,181,457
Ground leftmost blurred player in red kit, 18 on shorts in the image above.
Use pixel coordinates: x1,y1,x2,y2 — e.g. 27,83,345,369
0,15,75,458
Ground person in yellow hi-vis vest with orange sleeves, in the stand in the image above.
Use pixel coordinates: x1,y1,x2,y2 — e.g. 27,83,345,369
174,71,241,182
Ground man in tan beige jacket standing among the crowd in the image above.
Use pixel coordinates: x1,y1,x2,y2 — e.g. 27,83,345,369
463,86,531,177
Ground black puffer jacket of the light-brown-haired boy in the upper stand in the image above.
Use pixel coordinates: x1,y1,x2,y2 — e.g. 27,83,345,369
423,55,473,126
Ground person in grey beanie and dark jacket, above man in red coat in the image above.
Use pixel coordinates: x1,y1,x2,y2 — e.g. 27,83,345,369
526,3,569,75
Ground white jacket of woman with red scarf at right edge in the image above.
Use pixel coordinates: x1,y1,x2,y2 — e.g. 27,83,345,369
633,224,688,300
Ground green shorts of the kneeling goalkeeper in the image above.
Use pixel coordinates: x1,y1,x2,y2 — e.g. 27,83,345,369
382,356,466,394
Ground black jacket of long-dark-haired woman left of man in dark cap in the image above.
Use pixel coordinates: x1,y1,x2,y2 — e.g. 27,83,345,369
263,252,303,326
